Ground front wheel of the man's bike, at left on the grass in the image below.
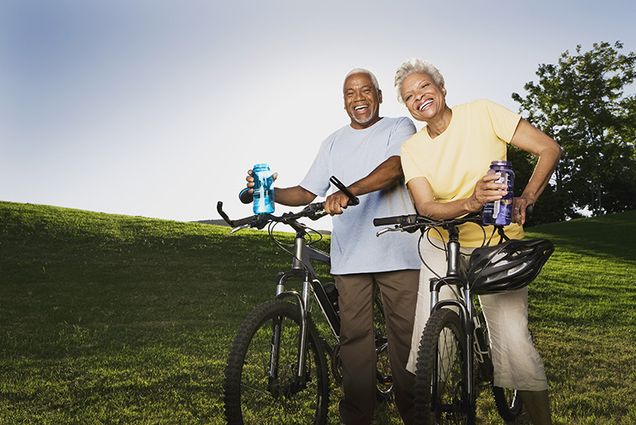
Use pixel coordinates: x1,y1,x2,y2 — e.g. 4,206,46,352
223,300,329,425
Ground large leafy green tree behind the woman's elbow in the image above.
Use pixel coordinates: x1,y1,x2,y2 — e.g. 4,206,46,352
511,41,636,222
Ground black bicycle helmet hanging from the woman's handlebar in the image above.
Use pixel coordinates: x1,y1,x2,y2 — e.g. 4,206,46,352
468,239,554,294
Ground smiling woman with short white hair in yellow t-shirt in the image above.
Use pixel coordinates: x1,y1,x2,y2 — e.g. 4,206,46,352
395,59,560,424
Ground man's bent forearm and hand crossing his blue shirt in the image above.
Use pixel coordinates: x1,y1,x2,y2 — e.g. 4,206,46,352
326,156,403,215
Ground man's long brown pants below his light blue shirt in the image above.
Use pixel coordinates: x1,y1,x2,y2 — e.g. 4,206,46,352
335,270,419,425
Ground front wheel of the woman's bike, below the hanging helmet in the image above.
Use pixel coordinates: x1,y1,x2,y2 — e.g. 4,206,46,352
414,308,475,425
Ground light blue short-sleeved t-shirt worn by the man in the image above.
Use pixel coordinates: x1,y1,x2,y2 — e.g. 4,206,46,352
300,117,421,275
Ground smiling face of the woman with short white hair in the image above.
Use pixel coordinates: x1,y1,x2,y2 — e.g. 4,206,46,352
400,72,446,122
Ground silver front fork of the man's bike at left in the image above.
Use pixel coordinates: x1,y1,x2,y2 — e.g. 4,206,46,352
268,272,310,392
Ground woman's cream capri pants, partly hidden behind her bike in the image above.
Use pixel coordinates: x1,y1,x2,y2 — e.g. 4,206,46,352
406,240,548,391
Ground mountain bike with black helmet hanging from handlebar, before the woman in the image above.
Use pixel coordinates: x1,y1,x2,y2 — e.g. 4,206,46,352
374,214,554,425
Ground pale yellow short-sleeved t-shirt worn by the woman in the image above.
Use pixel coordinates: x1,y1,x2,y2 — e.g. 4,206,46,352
401,100,523,247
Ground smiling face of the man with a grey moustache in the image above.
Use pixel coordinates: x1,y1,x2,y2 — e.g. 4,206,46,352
343,73,382,130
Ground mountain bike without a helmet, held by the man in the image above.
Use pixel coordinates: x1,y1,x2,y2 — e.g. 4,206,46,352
217,177,392,425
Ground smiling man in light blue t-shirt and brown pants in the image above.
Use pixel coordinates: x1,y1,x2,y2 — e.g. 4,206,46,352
247,69,420,425
